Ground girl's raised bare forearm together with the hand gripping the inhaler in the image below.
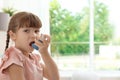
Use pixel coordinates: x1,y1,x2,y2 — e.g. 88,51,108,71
36,34,59,80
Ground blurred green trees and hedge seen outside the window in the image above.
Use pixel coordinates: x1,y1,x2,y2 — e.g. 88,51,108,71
50,0,113,55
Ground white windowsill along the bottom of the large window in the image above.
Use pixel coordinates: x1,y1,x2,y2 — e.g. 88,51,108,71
60,70,120,80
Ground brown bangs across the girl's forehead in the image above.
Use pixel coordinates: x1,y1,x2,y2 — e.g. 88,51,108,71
19,14,42,28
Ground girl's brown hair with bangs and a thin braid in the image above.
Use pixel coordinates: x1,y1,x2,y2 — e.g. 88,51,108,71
5,12,42,50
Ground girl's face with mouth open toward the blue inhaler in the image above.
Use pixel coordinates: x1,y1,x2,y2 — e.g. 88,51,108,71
10,27,40,53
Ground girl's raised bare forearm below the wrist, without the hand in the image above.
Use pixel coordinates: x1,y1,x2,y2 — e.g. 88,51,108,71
41,52,59,80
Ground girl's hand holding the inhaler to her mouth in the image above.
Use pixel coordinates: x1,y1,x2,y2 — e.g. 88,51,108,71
35,34,50,54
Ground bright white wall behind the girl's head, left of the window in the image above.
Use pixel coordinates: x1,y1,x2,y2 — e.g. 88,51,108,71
0,0,50,34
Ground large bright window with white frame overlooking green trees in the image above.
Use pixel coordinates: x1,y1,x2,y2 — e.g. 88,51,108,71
50,0,120,70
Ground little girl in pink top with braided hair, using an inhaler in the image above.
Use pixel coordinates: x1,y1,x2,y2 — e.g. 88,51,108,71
0,12,59,80
